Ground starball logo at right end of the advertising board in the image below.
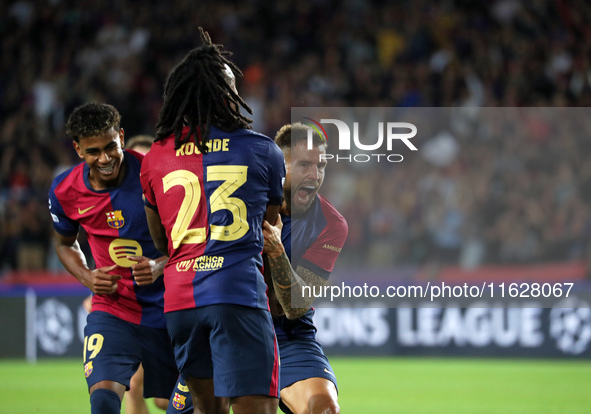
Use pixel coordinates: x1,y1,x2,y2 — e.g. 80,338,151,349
550,298,591,355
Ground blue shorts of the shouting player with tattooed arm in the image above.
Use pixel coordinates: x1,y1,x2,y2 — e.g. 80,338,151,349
279,339,338,390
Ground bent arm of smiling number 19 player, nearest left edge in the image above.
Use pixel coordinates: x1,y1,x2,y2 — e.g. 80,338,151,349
54,232,121,295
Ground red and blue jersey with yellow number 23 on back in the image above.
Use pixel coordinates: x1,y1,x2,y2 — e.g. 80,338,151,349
141,126,285,312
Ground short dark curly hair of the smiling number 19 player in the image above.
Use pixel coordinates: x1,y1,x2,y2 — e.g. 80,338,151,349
66,102,121,142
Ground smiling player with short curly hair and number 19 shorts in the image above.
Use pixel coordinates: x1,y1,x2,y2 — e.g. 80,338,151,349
49,103,178,414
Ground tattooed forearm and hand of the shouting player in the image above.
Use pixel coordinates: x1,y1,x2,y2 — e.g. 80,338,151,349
263,218,327,319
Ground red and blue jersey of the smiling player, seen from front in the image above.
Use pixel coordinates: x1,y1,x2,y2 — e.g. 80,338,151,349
49,150,166,328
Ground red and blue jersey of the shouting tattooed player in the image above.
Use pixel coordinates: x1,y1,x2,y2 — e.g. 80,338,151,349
274,194,348,341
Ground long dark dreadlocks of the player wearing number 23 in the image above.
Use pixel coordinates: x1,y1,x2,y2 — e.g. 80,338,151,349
155,27,252,154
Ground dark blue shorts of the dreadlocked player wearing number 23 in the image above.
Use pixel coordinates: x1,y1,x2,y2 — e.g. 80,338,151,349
166,304,279,398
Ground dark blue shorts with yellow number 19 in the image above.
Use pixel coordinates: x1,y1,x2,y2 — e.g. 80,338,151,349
83,311,178,399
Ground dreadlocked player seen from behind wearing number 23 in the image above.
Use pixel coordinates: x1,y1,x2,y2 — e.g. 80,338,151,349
141,28,285,414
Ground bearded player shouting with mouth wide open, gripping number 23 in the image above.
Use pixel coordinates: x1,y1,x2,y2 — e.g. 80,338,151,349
263,123,348,414
